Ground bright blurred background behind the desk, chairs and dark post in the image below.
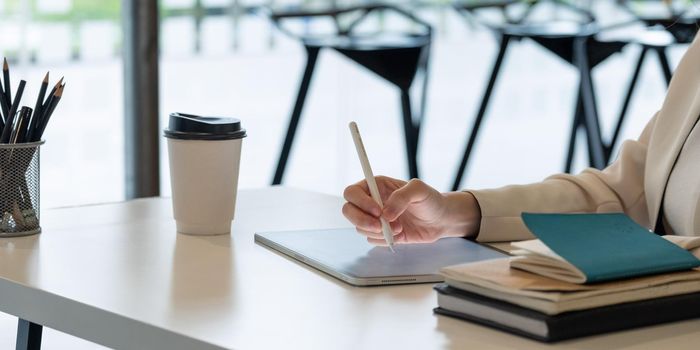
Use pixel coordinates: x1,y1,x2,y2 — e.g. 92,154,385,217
0,0,700,349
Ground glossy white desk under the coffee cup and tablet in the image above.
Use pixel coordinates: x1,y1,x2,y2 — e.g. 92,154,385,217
0,188,700,350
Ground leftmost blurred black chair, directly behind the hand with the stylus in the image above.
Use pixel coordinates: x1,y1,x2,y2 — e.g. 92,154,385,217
269,5,432,185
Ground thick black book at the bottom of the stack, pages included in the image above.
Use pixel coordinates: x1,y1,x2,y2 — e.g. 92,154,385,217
434,283,700,342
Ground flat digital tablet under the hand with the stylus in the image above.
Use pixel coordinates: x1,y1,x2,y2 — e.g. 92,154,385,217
255,228,507,286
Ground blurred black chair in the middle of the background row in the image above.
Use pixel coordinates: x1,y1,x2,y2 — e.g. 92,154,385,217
452,0,627,190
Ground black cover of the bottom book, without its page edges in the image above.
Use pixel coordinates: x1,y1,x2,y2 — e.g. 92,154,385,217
433,283,700,342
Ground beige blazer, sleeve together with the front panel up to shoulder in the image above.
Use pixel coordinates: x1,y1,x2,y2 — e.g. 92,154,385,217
469,36,700,242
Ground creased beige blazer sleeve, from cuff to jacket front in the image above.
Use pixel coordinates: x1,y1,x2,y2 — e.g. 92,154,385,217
469,115,656,242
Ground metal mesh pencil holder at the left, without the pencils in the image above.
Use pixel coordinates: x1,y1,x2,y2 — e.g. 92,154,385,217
0,141,44,237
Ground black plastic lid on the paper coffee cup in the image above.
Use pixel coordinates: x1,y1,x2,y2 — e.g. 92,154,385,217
164,113,246,140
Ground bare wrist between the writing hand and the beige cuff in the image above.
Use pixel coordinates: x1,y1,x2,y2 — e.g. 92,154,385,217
442,192,481,238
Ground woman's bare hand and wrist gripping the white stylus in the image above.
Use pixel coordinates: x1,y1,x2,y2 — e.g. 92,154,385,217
343,176,481,245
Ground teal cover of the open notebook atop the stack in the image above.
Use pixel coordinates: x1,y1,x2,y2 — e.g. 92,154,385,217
522,213,700,283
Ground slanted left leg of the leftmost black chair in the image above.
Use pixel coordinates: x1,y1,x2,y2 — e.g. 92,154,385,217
272,47,320,185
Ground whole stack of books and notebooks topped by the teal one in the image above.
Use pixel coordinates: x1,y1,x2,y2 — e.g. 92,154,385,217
435,214,700,342
